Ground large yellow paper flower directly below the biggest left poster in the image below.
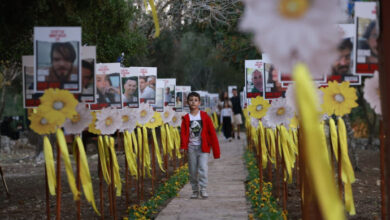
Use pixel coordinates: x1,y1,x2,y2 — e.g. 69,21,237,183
38,88,78,125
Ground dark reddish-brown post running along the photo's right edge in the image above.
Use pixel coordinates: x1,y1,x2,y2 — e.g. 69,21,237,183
377,0,390,217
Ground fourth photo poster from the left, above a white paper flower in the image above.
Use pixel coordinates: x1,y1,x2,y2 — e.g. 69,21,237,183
90,63,122,110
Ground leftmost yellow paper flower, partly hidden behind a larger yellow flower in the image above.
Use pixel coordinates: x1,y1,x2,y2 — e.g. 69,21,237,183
28,110,57,134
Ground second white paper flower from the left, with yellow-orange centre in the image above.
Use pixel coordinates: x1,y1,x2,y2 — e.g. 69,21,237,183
96,108,122,135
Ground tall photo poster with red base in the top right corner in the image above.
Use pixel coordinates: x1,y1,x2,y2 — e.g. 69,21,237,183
355,2,379,76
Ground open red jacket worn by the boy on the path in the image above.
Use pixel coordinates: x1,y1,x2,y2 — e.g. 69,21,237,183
180,111,221,159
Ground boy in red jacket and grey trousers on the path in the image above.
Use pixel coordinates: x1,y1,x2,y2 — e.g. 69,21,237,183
180,92,220,199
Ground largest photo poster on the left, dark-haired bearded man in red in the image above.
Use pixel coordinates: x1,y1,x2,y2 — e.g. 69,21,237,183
34,27,81,93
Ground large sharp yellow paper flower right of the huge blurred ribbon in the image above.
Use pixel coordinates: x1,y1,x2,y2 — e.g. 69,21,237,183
321,81,358,116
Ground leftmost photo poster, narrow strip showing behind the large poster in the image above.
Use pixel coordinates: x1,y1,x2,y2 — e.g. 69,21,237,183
22,55,43,108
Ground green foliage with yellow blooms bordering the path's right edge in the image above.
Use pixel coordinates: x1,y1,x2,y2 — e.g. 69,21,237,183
244,150,287,219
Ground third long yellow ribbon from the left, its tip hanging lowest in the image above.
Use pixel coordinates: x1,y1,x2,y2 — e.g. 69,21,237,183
73,135,100,216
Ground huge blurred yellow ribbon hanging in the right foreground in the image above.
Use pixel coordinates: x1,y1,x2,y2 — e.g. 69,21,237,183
293,64,344,220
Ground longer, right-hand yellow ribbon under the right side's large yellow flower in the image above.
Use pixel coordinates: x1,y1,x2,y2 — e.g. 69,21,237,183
337,117,356,215
